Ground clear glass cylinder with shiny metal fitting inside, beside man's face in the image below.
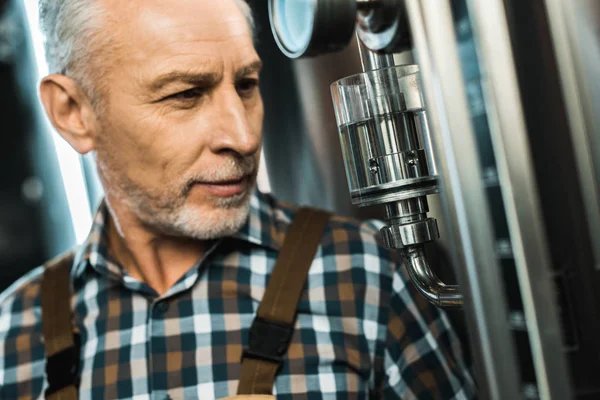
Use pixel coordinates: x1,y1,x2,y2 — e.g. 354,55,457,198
332,64,438,206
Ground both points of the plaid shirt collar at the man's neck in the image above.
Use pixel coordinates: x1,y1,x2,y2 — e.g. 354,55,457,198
72,189,289,278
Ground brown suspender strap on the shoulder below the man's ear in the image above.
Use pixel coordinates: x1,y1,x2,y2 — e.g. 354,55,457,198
41,252,79,400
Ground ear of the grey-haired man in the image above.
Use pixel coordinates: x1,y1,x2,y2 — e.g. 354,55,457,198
40,74,96,154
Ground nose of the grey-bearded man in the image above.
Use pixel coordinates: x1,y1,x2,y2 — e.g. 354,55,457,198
211,90,260,156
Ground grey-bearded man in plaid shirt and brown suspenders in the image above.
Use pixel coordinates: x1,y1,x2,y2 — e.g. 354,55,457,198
0,0,474,399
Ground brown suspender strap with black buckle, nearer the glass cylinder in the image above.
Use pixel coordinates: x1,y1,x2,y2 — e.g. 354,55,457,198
238,208,330,395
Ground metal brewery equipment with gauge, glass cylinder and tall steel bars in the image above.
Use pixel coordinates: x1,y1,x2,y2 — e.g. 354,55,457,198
269,0,600,400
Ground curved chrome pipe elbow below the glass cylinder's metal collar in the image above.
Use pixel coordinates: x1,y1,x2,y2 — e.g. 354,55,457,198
401,245,463,308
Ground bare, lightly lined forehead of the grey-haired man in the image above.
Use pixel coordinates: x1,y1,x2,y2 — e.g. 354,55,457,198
101,0,258,84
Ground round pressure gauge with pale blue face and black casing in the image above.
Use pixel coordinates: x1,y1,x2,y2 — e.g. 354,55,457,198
269,0,357,58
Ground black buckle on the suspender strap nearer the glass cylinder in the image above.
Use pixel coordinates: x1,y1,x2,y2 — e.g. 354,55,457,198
242,317,294,368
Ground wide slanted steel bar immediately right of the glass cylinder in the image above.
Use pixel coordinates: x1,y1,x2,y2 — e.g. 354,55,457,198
405,0,521,400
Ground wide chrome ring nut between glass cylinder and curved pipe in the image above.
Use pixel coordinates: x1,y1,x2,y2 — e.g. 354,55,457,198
381,218,440,249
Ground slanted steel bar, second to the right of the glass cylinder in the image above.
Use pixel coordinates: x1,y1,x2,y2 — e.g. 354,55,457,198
467,0,571,400
